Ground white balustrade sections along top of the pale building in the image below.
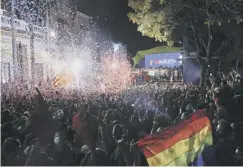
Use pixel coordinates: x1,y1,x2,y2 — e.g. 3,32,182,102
0,15,46,36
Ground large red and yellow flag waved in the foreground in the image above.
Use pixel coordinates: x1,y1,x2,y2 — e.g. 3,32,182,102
137,110,213,166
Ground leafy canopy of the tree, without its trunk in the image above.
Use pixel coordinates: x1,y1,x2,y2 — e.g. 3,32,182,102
128,0,243,45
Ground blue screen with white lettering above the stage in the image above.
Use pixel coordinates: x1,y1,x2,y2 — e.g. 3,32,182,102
145,52,182,68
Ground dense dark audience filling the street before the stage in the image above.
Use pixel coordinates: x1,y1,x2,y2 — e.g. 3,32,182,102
1,69,243,166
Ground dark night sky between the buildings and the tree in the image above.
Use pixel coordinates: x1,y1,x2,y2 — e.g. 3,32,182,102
78,0,161,56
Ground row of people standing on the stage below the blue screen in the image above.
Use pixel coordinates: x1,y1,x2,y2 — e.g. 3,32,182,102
133,67,183,83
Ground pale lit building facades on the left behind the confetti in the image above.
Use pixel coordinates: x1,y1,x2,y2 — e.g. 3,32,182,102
0,0,95,83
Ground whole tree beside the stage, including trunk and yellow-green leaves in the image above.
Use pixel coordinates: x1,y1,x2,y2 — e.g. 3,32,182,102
128,0,243,86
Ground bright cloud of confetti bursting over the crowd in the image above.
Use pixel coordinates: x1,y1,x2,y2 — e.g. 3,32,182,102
1,0,131,96
